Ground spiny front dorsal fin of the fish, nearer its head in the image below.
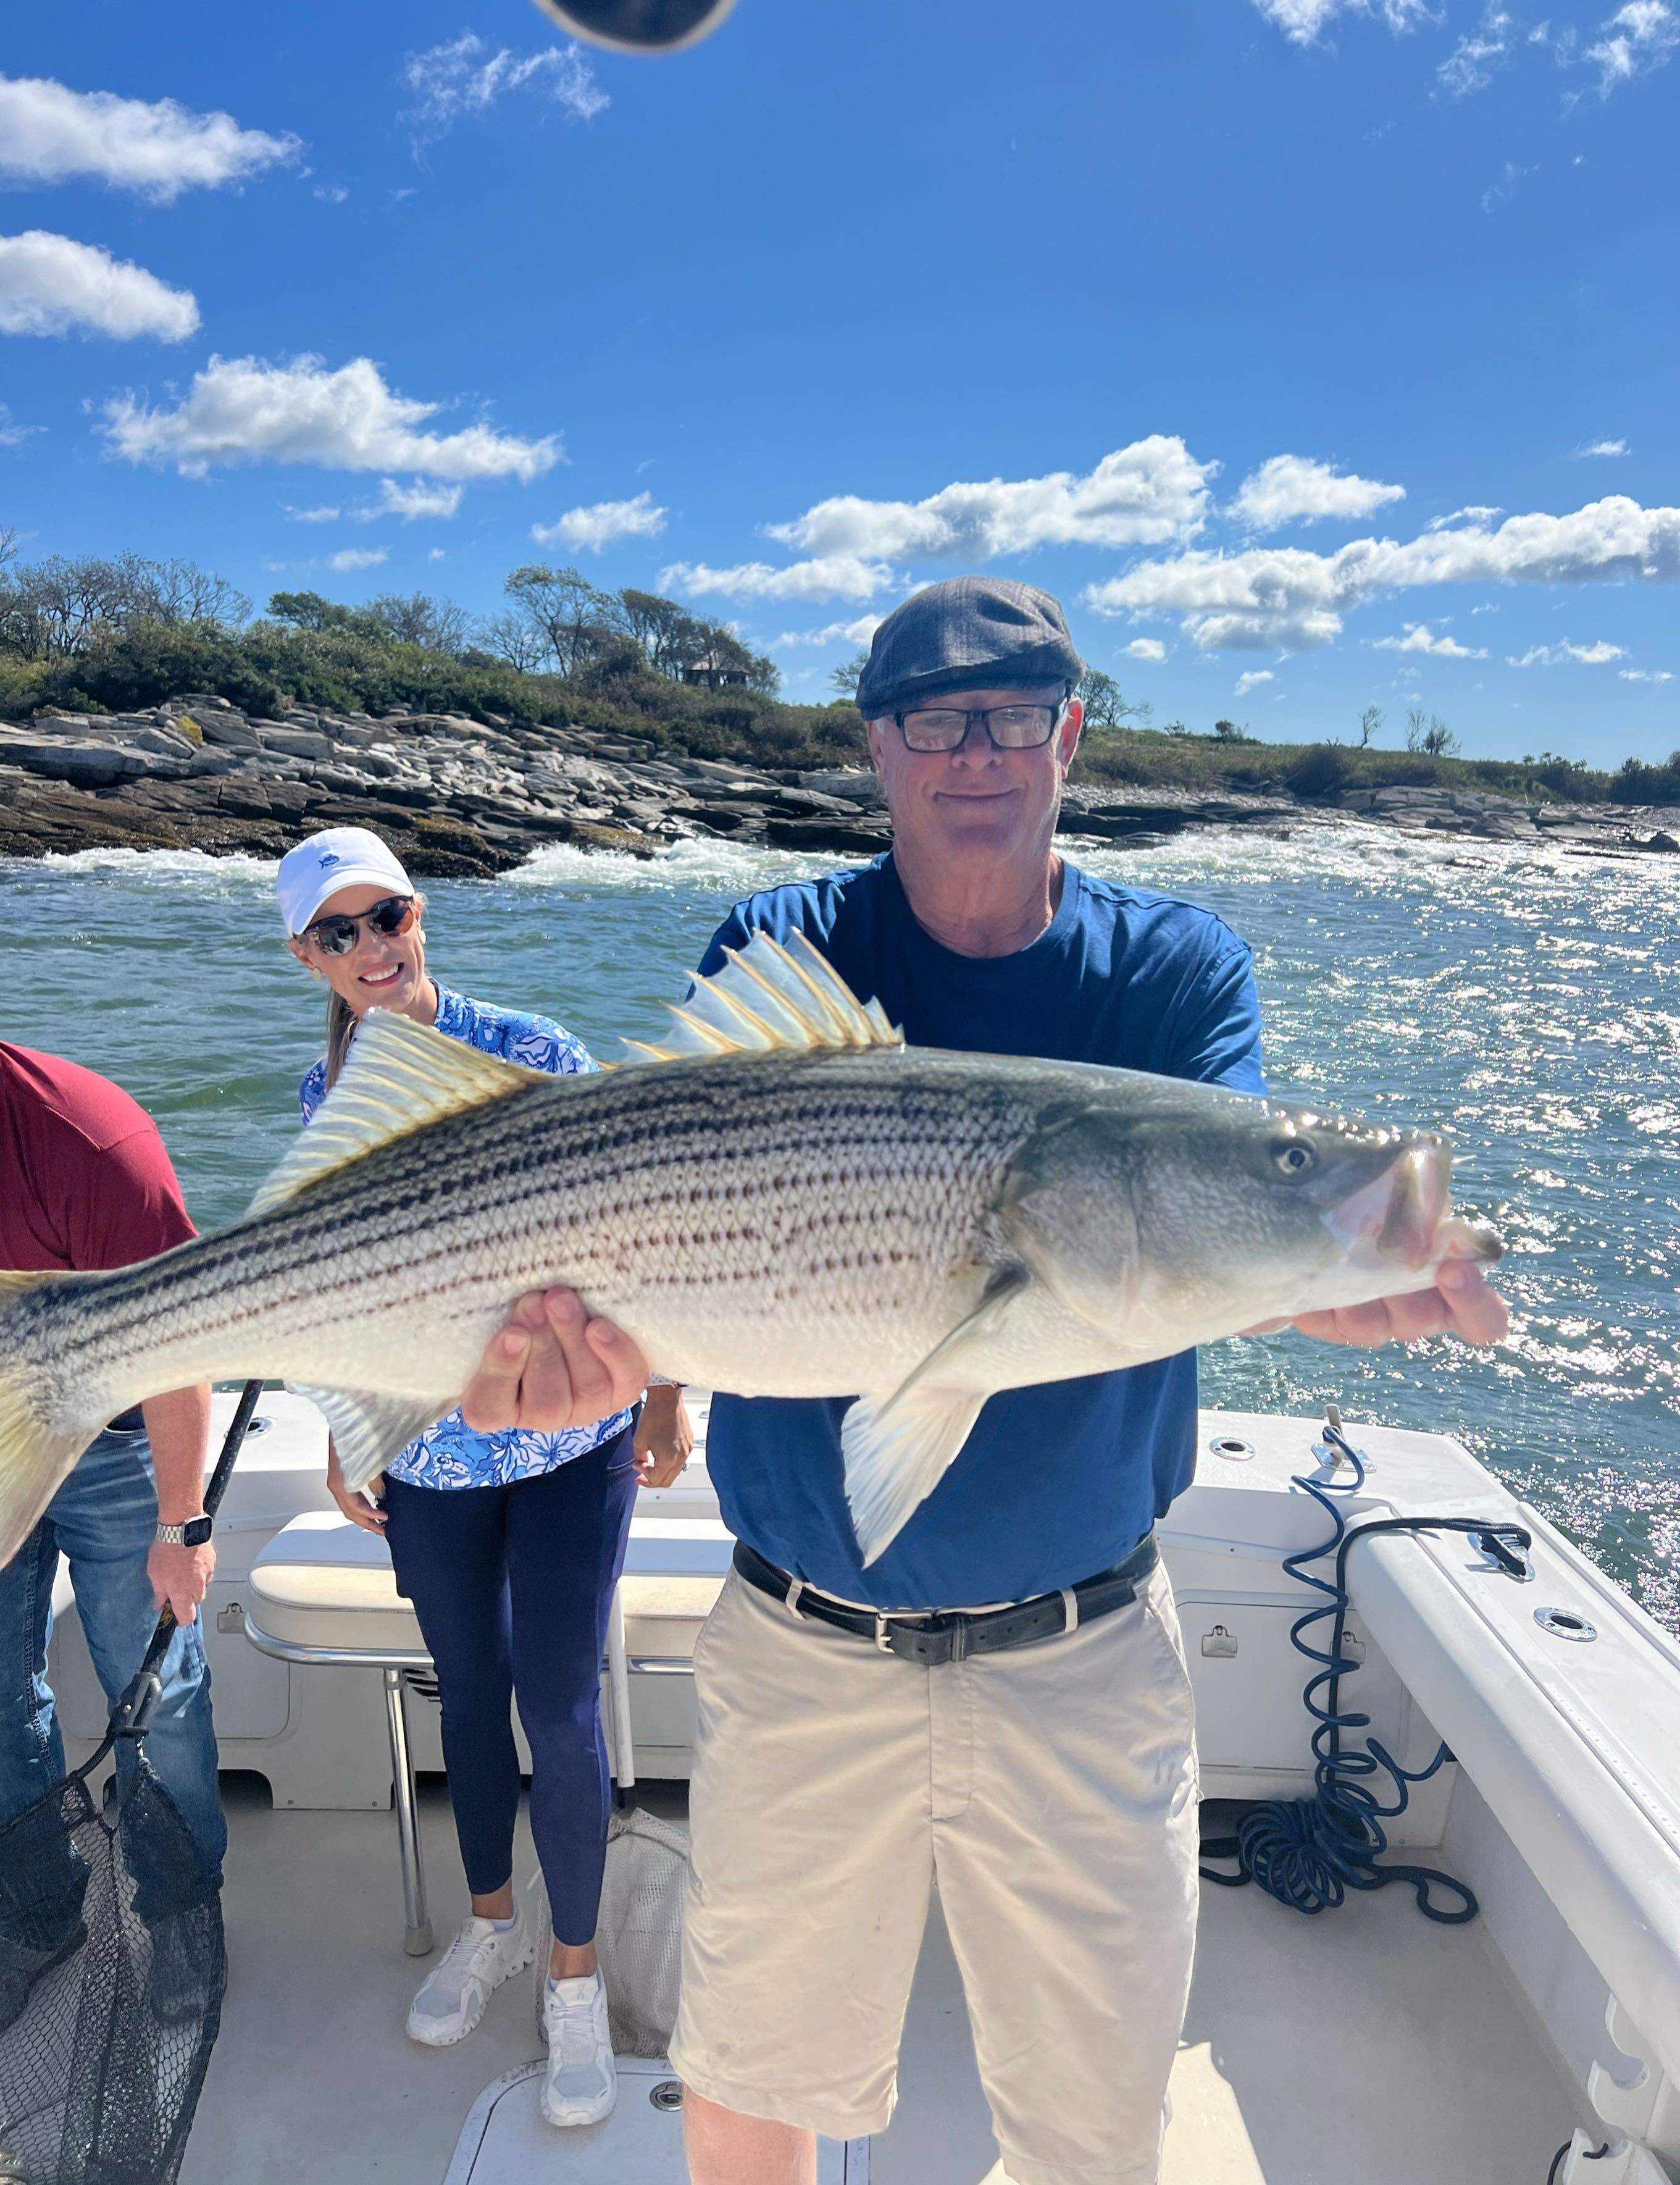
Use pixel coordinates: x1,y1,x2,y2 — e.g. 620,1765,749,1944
625,933,905,1062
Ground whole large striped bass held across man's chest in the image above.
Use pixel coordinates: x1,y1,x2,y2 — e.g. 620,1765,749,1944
0,933,1498,1562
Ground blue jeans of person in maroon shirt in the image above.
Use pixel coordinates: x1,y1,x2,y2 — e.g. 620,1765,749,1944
0,1431,227,1918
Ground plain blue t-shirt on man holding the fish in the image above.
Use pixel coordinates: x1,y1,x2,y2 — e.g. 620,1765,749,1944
701,854,1265,1608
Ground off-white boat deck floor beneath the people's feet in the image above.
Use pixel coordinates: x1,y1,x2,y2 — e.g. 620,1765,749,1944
182,1779,1582,2185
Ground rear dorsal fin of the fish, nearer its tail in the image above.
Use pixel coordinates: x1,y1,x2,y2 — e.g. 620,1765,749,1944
247,1010,551,1215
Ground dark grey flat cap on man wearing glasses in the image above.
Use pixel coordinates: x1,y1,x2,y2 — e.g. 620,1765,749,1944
859,577,1086,721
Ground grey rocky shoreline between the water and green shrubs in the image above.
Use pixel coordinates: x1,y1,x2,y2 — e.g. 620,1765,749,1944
0,693,1680,878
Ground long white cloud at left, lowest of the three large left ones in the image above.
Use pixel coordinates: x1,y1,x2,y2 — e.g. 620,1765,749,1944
105,356,561,483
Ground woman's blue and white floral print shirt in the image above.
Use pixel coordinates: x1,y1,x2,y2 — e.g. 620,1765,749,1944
297,983,632,1488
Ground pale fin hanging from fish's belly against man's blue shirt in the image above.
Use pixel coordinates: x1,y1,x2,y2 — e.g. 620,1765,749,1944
841,1267,1034,1569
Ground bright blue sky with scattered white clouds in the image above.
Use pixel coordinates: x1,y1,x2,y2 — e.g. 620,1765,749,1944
0,0,1680,765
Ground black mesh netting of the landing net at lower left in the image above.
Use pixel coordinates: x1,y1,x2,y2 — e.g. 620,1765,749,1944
0,1746,227,2185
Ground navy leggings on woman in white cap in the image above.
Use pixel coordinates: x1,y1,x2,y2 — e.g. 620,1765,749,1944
385,1427,636,1942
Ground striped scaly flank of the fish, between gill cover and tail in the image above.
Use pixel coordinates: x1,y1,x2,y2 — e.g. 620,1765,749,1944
29,1049,1062,1385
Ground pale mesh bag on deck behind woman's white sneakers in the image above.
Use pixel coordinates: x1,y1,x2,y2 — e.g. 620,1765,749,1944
537,1809,688,2053
